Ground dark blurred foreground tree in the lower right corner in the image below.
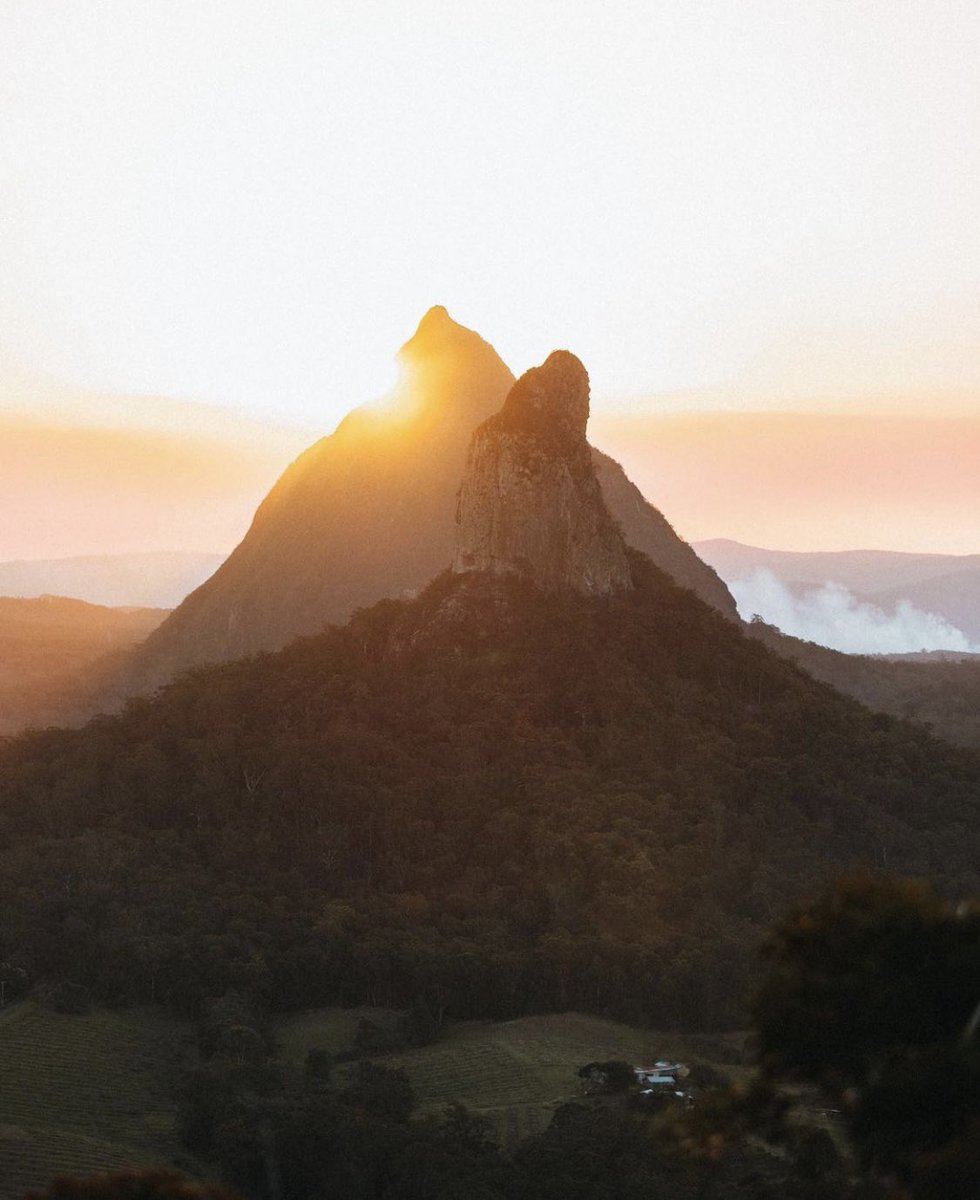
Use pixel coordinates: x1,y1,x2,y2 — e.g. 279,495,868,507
754,874,980,1200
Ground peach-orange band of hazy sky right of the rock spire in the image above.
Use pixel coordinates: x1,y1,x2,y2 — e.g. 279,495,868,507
589,413,980,554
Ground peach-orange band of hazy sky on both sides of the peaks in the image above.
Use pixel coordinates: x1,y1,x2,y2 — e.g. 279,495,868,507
0,398,980,560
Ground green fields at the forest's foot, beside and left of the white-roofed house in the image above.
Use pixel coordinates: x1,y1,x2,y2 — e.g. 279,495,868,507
275,1009,740,1148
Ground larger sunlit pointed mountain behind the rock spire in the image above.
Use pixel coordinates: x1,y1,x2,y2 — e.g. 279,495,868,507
120,307,736,694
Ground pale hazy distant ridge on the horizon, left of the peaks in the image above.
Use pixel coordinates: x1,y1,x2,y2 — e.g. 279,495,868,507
0,551,222,608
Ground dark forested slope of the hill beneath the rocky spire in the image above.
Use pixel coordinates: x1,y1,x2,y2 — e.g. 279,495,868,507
0,556,980,1028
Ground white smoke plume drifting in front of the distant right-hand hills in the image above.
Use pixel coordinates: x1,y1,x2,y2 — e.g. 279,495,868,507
728,568,980,654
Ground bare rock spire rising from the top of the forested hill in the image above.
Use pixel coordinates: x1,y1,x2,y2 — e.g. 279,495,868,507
453,350,632,594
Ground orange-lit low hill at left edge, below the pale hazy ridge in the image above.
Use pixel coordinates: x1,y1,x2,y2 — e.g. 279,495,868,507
0,596,167,734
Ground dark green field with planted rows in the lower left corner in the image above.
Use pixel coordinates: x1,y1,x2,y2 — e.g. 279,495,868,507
0,1002,196,1200
